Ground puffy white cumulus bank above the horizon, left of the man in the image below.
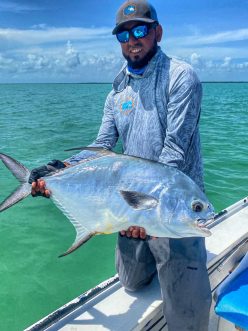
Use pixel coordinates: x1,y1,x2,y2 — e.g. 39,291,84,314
0,41,123,82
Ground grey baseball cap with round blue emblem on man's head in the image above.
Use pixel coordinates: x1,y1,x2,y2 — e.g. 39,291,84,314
112,0,158,34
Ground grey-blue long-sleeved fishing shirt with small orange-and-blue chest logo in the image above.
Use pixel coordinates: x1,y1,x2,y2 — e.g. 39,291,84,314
67,48,204,189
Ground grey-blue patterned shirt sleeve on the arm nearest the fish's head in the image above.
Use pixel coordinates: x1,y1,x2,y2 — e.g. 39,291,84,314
159,66,202,170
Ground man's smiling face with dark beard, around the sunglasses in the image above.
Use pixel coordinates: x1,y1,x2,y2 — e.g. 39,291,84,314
120,22,162,69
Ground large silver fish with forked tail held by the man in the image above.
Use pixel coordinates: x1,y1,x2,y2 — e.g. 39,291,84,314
0,147,214,256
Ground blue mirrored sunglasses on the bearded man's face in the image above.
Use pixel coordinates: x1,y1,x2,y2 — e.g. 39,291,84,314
116,23,158,44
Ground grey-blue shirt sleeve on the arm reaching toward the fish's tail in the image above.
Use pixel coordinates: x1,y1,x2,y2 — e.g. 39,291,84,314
65,92,119,164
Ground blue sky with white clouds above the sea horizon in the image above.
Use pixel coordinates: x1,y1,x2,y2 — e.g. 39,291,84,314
0,0,248,83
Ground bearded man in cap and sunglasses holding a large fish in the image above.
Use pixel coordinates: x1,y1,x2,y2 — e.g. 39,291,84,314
30,0,211,331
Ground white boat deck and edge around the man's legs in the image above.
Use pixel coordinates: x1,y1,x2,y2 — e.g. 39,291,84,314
26,198,248,331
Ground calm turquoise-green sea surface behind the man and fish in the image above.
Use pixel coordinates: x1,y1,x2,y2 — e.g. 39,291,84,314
0,83,248,331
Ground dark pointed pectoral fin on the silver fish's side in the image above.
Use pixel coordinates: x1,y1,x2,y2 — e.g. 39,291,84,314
120,191,158,210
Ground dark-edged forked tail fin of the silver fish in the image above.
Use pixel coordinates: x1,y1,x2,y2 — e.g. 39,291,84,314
0,153,31,212
